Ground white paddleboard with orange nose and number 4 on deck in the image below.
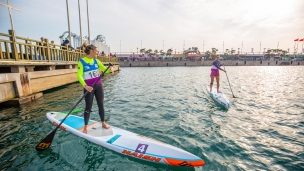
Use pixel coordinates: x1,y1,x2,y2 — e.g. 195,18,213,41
46,112,205,167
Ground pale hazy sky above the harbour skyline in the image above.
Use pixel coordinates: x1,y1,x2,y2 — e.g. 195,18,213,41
0,0,304,52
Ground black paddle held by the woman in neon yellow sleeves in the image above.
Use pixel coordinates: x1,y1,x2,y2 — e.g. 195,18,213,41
36,63,112,151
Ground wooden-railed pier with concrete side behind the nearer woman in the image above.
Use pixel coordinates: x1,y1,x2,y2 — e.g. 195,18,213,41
0,31,120,106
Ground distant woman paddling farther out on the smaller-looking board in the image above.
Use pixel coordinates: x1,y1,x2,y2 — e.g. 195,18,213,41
210,55,226,93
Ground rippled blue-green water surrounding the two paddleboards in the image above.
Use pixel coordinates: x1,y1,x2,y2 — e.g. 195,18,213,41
0,66,304,171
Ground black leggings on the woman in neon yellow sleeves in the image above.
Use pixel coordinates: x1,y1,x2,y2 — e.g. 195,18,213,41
84,83,105,125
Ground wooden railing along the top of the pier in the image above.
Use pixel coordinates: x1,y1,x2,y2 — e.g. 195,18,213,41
0,30,118,63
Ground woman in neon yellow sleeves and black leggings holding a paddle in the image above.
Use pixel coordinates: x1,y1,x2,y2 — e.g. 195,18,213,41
77,45,113,134
